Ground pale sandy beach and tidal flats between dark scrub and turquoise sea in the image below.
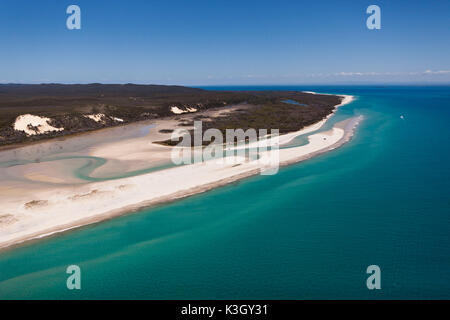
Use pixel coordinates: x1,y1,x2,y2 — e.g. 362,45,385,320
0,96,360,247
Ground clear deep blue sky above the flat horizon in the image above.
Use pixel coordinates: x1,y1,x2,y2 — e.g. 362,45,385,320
0,0,450,85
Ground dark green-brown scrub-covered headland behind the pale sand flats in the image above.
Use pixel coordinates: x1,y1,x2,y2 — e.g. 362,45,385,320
0,83,341,145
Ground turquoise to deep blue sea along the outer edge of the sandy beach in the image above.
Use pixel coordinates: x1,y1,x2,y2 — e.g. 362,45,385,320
0,87,450,299
